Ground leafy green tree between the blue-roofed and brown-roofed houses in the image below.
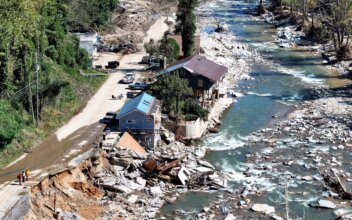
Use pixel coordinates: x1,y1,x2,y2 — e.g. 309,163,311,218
150,73,193,115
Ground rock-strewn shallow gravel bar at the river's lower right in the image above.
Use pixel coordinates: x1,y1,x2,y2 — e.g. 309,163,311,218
188,87,352,219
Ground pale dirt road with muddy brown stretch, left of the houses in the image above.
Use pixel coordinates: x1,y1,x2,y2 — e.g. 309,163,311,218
0,17,168,219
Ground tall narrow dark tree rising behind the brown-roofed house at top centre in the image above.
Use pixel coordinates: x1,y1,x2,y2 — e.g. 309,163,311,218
176,0,199,57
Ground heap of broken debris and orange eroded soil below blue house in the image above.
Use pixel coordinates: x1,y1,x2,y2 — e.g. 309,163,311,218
27,133,227,219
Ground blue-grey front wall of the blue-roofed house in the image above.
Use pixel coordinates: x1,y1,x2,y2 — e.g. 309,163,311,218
119,110,154,132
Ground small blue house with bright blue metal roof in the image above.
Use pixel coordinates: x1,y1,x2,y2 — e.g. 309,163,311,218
116,93,161,147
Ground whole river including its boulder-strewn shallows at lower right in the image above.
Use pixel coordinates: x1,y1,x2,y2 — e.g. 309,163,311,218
161,1,351,219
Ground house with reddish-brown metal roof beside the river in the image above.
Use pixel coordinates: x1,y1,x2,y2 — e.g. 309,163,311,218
162,55,228,107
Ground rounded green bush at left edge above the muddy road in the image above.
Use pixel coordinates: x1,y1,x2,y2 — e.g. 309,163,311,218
0,100,24,147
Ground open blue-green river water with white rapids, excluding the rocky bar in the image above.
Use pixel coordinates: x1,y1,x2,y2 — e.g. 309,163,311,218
161,0,350,220
